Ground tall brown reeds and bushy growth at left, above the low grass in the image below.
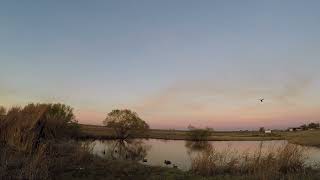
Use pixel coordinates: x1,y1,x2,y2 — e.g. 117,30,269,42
0,104,78,152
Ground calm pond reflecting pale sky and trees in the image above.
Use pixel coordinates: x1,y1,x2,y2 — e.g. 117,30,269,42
85,139,320,170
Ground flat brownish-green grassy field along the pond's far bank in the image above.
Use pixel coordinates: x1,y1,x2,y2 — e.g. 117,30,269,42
81,125,320,147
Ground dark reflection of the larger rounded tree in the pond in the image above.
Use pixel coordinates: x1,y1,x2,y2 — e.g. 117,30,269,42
104,140,151,161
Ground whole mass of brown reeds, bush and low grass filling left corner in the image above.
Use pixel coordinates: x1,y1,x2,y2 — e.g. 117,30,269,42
0,104,84,179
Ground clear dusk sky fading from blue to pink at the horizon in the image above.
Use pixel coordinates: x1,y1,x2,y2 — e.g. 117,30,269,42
0,0,320,130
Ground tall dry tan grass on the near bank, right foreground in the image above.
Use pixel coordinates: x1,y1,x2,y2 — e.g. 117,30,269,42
191,144,307,179
